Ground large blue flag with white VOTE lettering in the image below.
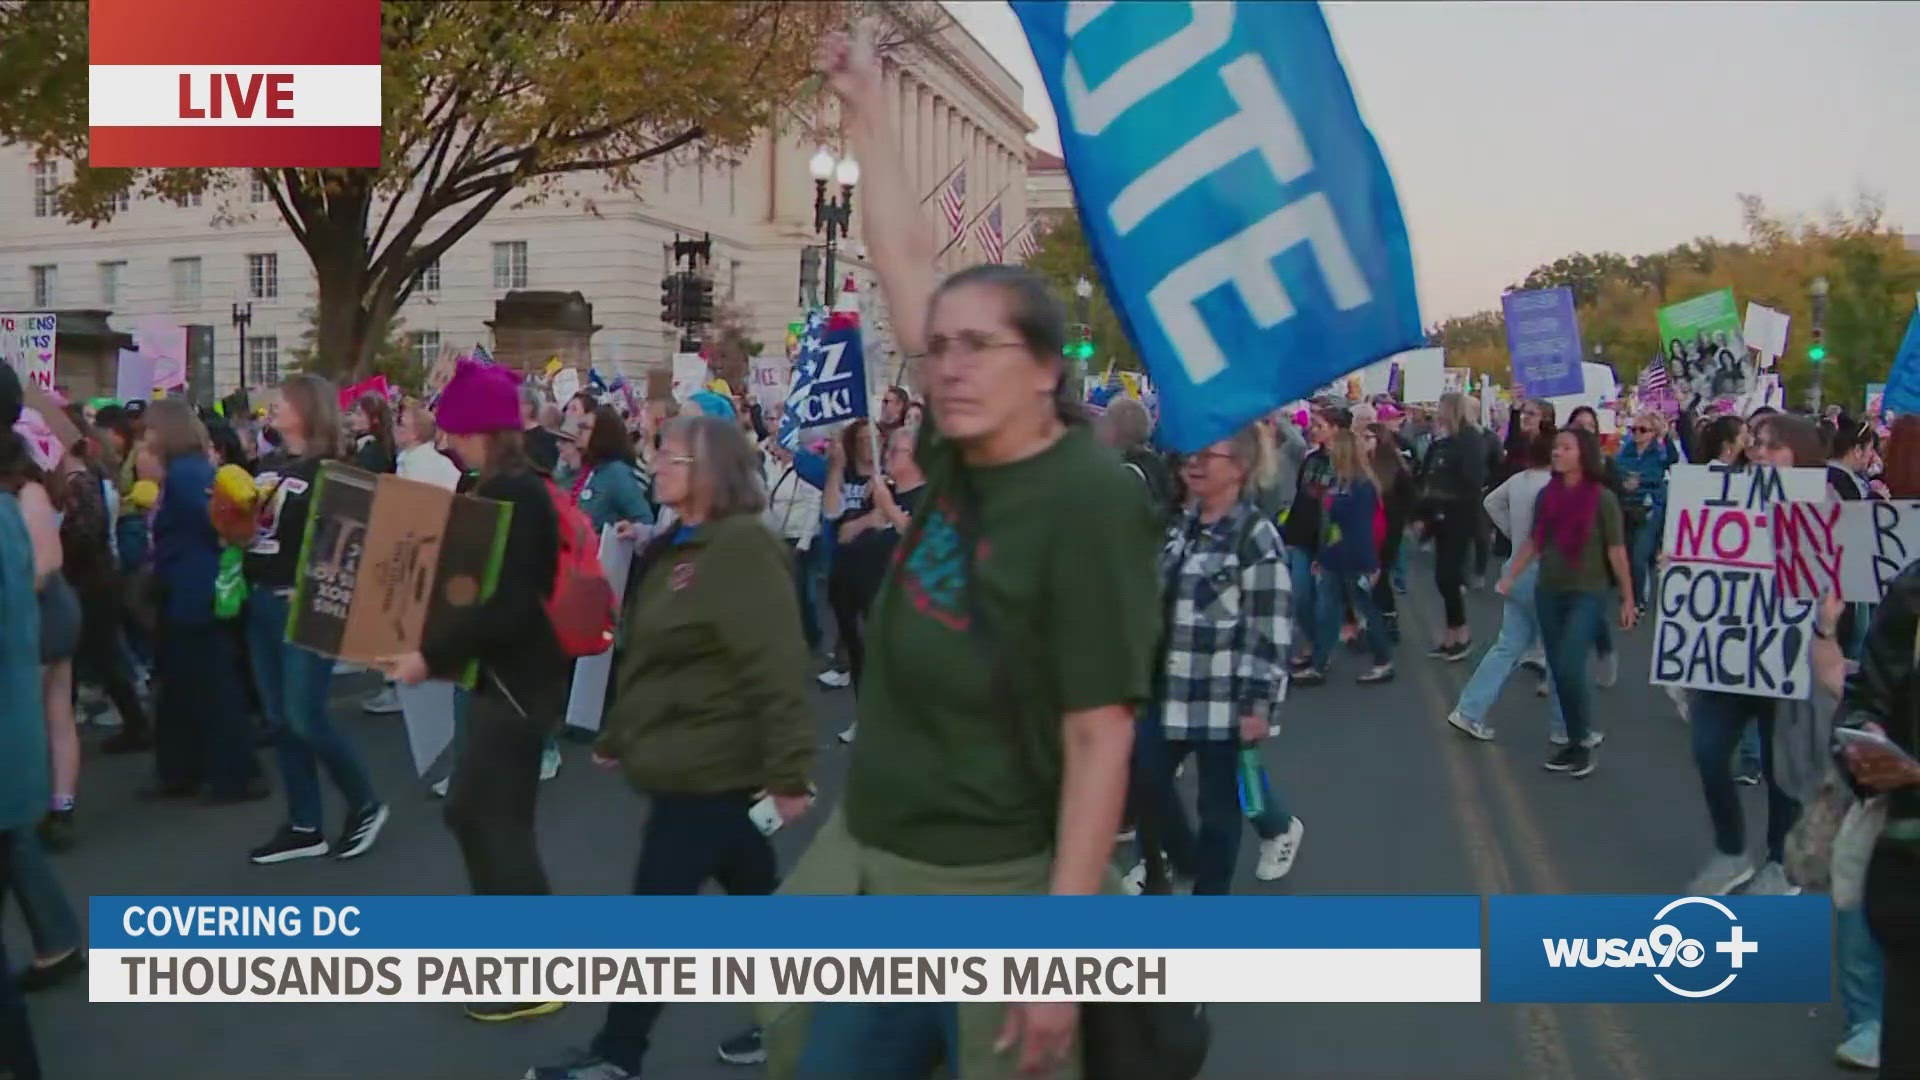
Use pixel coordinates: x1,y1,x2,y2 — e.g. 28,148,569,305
1014,0,1425,452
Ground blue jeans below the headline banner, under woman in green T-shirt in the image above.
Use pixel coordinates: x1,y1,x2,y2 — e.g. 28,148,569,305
795,1001,960,1080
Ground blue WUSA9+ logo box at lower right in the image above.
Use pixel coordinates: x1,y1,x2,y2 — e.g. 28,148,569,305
1486,896,1832,1001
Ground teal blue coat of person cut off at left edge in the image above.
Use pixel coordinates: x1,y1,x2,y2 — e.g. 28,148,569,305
0,492,48,832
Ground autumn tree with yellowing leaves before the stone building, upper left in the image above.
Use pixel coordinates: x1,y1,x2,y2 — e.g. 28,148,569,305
0,0,941,379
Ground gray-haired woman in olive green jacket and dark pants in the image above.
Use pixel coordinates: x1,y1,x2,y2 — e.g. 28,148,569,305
528,415,814,1080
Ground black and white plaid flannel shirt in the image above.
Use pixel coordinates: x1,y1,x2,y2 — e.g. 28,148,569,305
1154,500,1292,742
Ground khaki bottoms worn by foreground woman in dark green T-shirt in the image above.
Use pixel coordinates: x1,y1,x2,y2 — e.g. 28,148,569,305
755,807,1119,1080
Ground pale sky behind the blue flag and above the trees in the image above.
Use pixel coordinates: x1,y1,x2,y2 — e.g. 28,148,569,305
947,0,1920,323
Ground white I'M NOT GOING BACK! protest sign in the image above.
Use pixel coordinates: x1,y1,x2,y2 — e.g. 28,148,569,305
1651,465,1826,700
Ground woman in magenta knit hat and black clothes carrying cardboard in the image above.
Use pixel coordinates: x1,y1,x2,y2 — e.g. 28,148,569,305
384,361,572,1020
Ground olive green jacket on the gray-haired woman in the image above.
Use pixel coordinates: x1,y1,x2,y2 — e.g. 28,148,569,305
597,513,814,796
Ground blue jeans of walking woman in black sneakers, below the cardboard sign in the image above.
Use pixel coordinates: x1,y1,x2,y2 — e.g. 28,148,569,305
248,588,378,828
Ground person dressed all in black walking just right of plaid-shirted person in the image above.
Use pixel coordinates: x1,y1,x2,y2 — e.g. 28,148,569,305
1419,394,1486,661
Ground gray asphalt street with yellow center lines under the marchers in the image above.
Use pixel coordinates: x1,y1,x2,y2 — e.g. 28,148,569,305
6,569,1866,1080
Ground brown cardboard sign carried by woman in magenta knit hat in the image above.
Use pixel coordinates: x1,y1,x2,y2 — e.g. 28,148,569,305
286,463,513,663
